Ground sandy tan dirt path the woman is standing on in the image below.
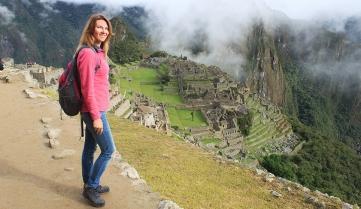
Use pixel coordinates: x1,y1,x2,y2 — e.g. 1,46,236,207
0,81,159,209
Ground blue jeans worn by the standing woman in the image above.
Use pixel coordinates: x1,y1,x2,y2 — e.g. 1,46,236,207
81,112,115,188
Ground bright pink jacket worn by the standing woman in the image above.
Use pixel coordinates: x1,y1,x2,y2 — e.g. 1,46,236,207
77,48,109,121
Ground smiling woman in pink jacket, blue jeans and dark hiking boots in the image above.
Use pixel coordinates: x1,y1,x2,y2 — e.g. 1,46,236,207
77,14,115,207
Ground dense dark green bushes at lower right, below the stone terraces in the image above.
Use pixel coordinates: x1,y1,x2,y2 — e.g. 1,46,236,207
261,133,361,204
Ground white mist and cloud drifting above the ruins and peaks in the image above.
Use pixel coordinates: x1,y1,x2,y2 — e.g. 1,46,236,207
36,0,361,80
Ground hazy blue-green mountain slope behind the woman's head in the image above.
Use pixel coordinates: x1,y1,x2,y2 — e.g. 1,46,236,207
0,0,146,66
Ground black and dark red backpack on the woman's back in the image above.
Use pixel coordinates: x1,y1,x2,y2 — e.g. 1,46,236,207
58,46,98,116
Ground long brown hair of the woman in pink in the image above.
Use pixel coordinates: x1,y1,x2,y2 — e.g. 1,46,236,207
77,14,113,56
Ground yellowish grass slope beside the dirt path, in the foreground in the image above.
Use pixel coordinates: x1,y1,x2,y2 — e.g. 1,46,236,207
109,115,335,209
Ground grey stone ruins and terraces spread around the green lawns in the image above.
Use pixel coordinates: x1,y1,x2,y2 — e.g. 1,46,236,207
125,56,297,159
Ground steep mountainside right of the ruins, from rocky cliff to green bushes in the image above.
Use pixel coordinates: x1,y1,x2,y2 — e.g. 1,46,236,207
246,20,361,203
